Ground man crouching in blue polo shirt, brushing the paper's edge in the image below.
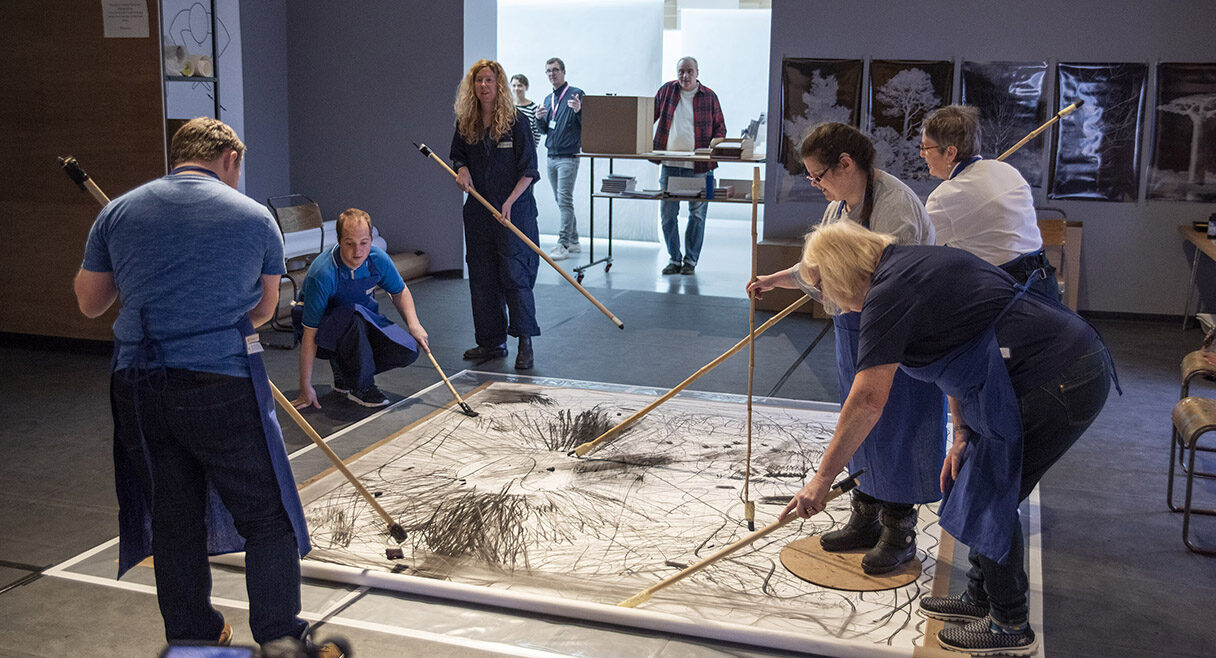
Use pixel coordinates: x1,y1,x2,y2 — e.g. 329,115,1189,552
292,208,430,409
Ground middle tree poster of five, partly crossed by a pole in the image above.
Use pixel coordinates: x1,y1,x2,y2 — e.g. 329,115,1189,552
962,62,1047,187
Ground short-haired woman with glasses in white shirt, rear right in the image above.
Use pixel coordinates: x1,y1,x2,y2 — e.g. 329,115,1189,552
921,105,1060,300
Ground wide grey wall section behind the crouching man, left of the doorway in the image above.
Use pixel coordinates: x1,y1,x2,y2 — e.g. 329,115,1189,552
286,0,465,270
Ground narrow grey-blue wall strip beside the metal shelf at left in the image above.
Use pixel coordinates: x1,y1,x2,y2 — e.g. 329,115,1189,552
241,0,292,202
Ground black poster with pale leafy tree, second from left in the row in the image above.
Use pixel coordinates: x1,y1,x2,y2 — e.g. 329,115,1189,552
869,60,955,195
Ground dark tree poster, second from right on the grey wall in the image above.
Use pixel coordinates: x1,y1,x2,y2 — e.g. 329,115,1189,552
1047,63,1148,202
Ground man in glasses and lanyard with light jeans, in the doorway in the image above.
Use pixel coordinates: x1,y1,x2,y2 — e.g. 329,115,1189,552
536,57,582,260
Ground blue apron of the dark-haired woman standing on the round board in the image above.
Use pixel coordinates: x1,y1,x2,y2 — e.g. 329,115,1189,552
832,313,946,504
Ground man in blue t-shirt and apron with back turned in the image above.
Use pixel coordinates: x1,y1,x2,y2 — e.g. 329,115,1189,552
75,118,337,656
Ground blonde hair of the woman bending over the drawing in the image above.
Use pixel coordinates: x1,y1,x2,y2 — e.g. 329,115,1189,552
799,220,895,308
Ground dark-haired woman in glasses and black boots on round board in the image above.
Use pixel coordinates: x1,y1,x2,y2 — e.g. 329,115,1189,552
748,123,946,574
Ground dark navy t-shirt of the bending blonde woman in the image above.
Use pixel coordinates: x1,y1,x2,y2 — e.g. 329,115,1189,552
857,244,1097,395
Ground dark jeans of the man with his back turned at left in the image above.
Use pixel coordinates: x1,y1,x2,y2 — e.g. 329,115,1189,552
111,369,308,643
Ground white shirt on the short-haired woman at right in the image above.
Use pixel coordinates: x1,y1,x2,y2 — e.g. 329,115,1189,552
924,159,1043,265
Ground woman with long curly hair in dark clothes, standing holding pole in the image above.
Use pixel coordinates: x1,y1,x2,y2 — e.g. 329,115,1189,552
451,60,540,370
